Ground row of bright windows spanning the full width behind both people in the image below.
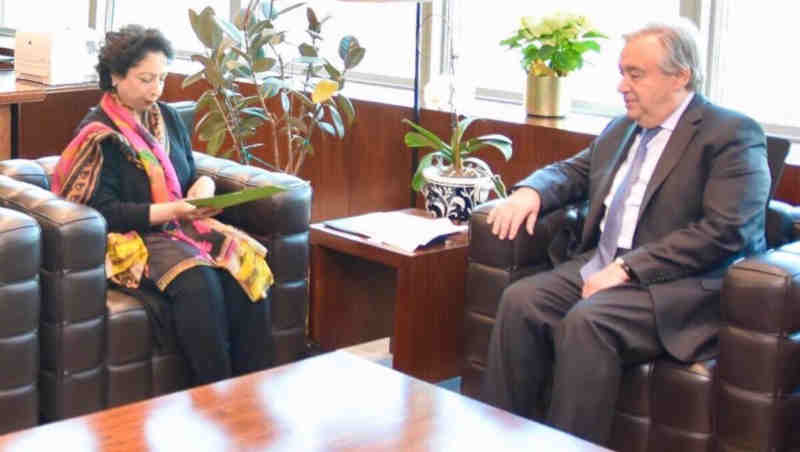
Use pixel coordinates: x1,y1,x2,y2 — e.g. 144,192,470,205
0,0,800,142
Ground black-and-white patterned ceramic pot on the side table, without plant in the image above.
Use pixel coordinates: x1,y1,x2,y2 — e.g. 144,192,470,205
422,159,492,223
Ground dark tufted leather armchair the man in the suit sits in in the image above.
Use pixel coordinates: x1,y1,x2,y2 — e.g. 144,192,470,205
461,137,800,452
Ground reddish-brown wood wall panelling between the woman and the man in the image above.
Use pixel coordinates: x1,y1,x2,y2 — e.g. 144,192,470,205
163,75,593,222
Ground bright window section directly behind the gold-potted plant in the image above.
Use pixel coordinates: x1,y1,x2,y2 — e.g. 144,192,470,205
455,0,680,116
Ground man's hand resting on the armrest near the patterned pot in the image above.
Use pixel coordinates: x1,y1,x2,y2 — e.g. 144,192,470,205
486,187,542,240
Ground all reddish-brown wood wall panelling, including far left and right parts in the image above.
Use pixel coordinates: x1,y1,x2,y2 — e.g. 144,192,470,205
19,75,784,222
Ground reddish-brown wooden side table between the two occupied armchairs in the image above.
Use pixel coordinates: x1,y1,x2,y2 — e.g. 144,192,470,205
309,209,468,381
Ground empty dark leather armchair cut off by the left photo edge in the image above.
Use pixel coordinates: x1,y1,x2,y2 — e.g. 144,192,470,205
0,208,42,434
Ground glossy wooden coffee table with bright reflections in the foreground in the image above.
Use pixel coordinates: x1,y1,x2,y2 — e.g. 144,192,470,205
0,351,607,452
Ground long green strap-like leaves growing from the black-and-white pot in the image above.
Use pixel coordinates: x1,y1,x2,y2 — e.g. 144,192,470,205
403,117,513,198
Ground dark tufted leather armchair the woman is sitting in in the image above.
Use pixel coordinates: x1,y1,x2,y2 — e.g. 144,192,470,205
0,103,311,421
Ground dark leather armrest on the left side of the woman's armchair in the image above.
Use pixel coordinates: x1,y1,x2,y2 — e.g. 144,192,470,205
0,176,107,419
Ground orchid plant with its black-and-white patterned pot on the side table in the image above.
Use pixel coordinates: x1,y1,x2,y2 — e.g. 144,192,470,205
403,117,512,222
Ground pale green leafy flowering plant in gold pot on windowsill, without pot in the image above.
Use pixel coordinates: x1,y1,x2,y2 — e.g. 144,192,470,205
500,13,607,77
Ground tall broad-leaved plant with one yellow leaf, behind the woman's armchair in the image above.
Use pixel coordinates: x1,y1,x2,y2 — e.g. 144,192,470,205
183,0,366,174
